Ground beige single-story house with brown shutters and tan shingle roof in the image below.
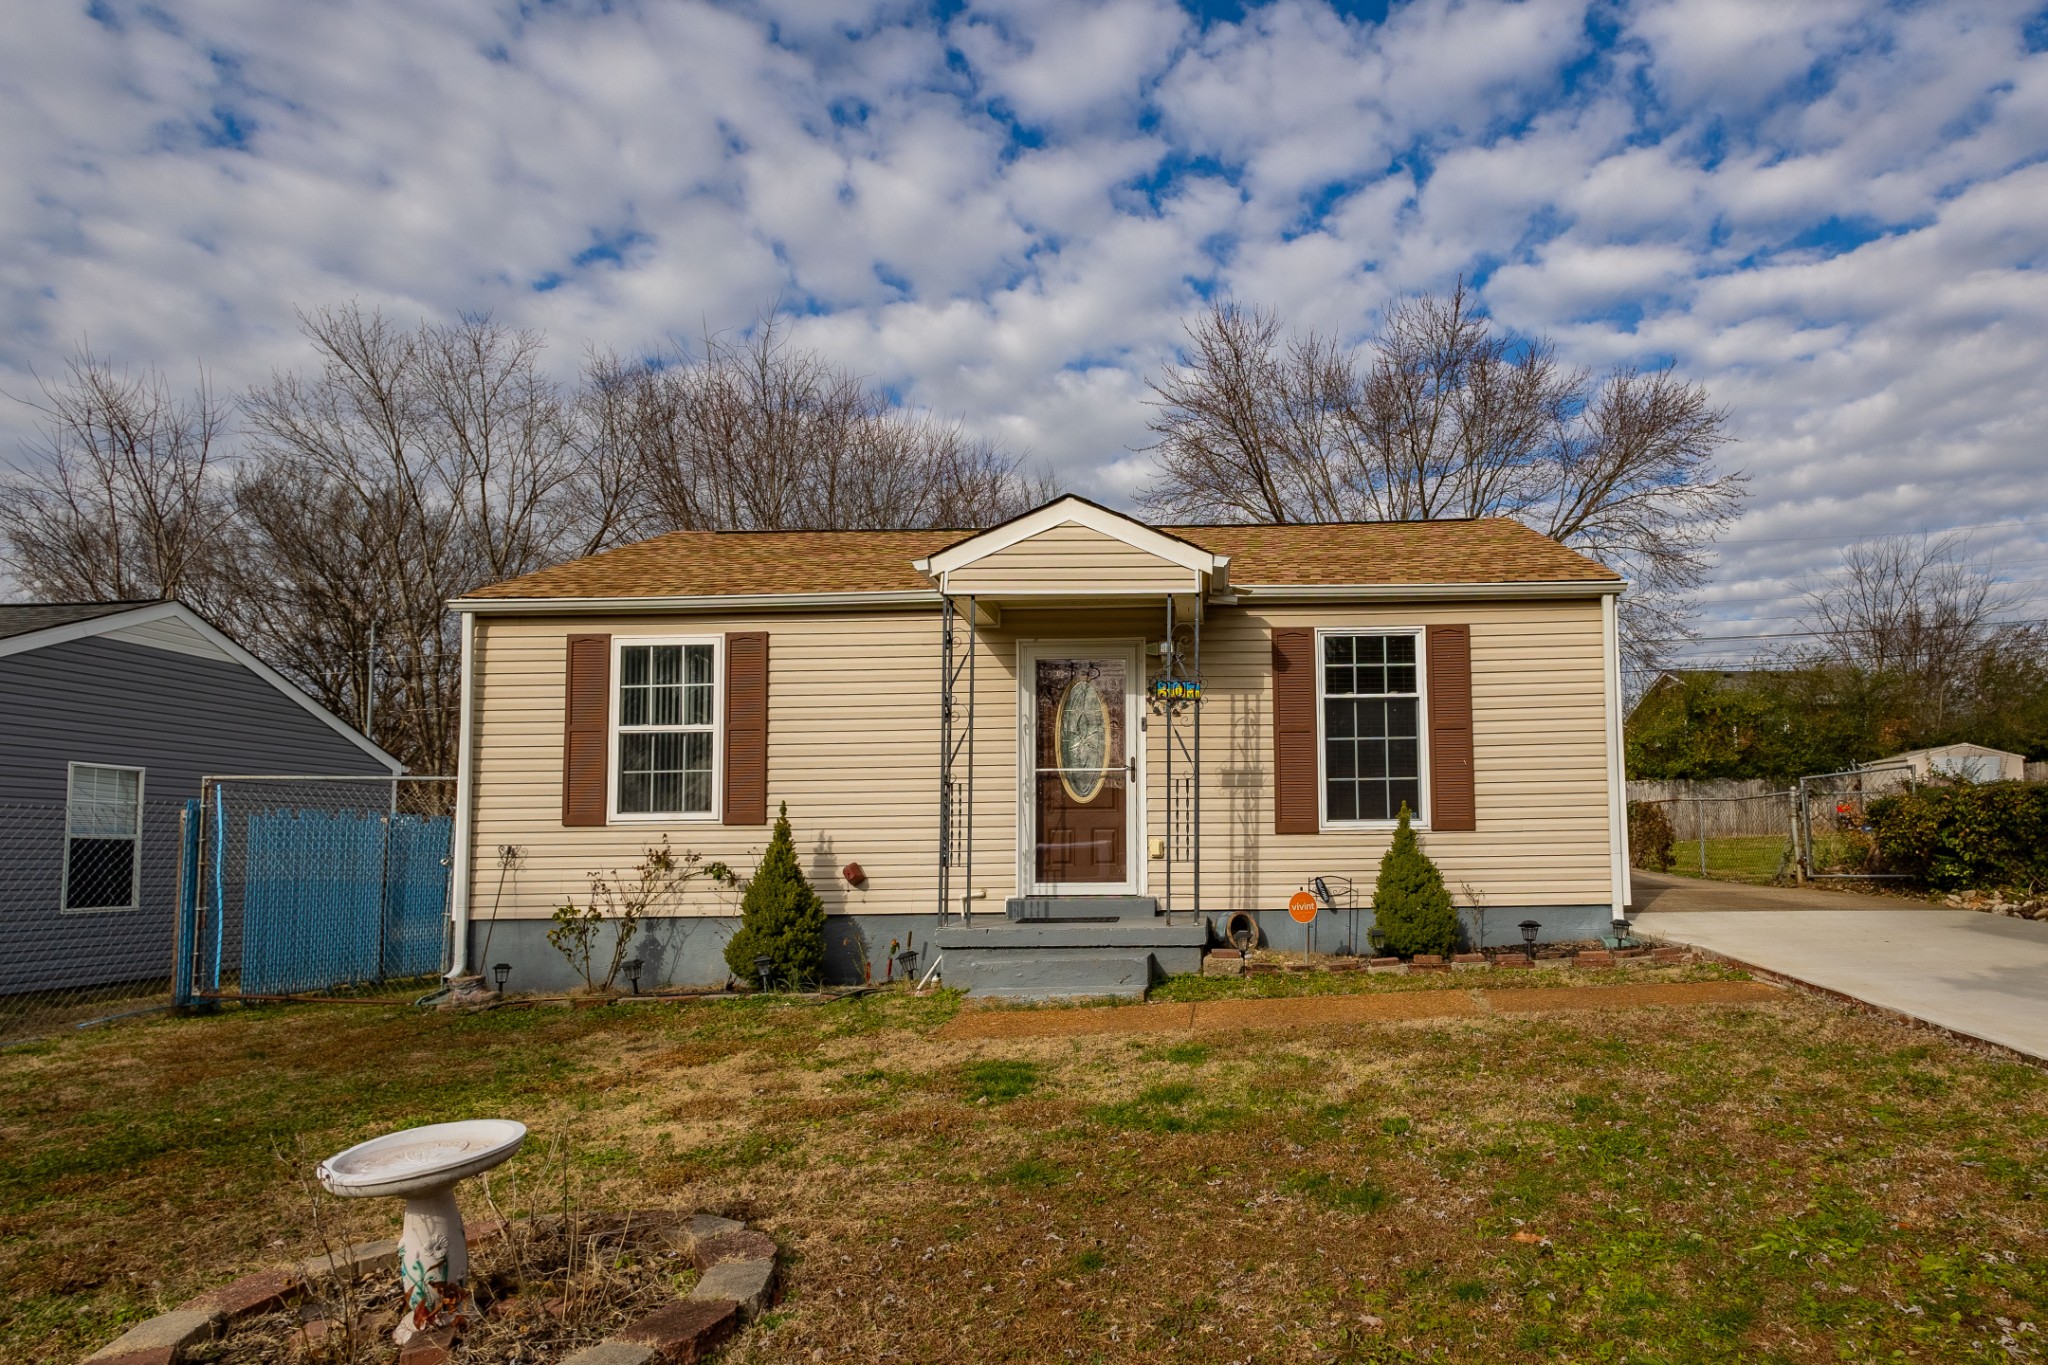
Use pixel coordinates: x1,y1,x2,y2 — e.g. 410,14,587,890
453,497,1628,995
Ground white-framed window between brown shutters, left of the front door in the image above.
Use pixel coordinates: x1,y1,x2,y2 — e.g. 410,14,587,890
612,639,719,819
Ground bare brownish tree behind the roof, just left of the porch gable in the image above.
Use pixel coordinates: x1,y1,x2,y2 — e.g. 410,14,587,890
602,313,1053,530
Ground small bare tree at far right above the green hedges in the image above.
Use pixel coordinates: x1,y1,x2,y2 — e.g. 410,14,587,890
1806,532,2036,731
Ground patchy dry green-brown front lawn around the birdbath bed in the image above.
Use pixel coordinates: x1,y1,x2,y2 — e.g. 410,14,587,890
0,970,2048,1363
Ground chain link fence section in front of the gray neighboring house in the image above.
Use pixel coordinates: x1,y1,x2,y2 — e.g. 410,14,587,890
0,792,186,1044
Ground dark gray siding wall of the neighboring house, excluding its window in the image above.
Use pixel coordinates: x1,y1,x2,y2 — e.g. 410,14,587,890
0,639,385,995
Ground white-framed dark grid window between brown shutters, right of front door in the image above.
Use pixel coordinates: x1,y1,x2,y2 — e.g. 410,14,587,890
1321,630,1423,825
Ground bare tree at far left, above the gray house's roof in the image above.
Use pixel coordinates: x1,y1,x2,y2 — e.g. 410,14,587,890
0,348,231,608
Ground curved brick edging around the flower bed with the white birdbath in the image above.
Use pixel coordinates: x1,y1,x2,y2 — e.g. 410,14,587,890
84,1212,778,1365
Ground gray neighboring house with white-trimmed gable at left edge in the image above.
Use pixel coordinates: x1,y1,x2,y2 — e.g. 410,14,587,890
0,602,403,995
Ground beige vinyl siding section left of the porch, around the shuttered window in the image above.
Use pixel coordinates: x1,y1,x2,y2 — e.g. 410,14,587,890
471,612,938,919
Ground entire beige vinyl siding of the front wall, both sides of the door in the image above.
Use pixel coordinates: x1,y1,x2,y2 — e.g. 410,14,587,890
471,600,1612,919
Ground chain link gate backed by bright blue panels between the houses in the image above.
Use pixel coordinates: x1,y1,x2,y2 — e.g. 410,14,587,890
176,776,455,1003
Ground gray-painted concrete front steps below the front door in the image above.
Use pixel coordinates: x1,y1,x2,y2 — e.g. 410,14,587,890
932,917,1208,1001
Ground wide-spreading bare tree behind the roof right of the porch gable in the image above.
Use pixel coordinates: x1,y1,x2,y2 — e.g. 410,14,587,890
1143,284,1743,657
